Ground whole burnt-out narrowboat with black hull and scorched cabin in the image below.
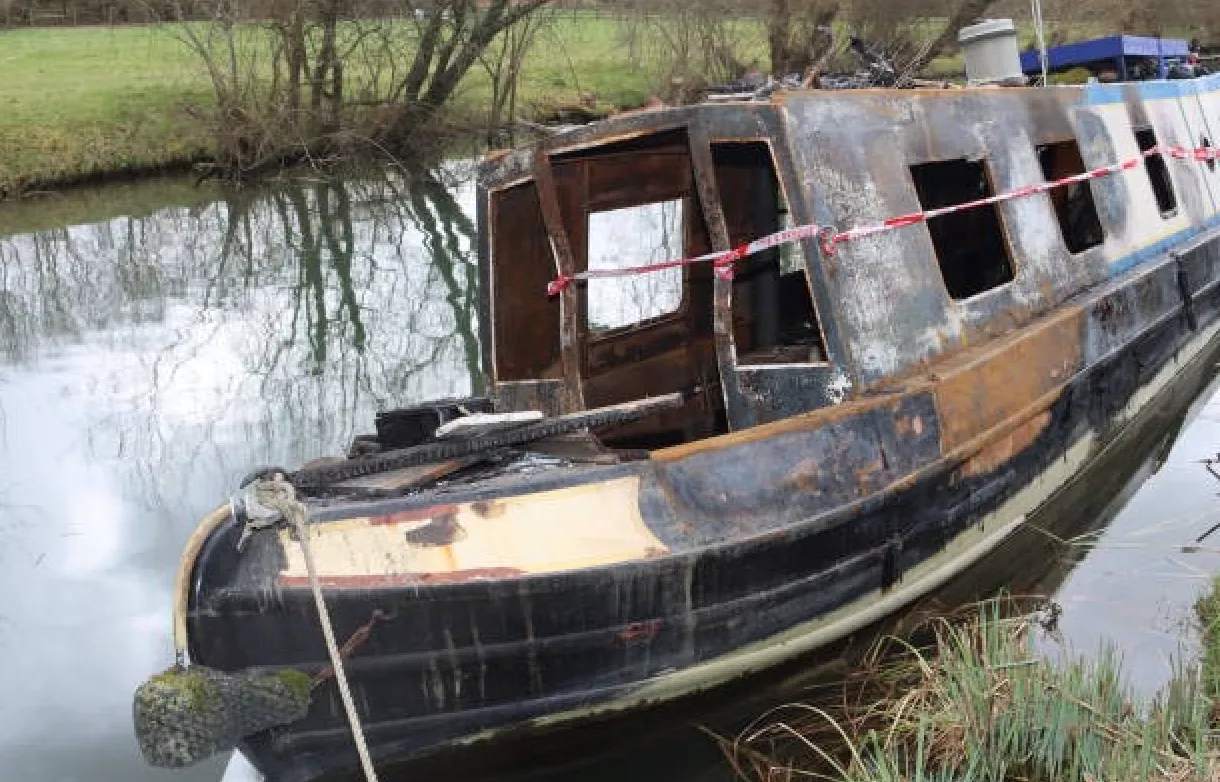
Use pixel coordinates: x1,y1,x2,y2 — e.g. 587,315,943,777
157,78,1220,782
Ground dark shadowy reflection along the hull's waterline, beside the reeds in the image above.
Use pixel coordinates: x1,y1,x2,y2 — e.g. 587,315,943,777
325,356,1220,782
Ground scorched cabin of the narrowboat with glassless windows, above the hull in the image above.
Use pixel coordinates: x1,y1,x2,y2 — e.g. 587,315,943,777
478,77,1220,448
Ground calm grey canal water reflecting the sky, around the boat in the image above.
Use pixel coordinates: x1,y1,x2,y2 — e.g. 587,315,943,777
0,172,1220,782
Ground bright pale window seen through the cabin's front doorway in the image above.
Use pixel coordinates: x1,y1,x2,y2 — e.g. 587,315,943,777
588,199,686,332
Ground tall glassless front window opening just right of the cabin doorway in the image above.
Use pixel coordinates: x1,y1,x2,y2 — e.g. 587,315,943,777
712,142,826,366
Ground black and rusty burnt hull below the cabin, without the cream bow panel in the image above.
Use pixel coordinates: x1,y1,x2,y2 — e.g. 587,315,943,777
189,225,1220,782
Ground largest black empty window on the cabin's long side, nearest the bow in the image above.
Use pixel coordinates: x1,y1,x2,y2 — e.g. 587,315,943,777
910,159,1013,299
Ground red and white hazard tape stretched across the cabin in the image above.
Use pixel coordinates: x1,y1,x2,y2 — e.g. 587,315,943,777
547,145,1220,296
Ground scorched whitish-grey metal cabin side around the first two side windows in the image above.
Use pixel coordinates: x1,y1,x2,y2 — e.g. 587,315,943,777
787,89,1104,388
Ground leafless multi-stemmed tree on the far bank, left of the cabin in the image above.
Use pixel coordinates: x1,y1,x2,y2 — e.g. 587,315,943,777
162,0,550,176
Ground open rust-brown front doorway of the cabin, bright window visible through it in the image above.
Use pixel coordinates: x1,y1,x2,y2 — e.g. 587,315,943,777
553,134,725,447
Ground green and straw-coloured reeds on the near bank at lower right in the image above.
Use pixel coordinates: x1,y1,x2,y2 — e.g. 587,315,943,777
720,595,1220,782
